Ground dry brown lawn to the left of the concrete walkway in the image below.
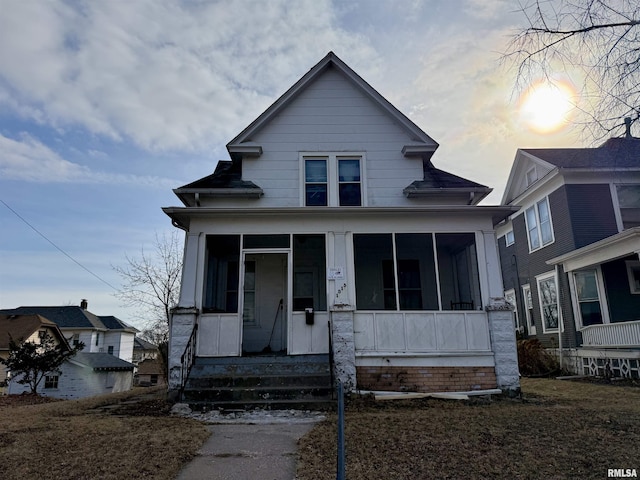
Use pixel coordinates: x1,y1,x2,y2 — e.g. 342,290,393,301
0,389,209,480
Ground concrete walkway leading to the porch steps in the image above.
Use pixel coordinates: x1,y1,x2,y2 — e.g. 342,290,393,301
177,421,314,480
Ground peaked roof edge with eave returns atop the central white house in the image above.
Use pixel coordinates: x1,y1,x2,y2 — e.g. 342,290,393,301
227,52,438,158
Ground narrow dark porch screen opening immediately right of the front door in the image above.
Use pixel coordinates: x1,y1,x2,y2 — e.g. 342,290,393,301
293,235,327,311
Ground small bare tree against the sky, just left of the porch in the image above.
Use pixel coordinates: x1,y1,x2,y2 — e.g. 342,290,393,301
113,231,182,345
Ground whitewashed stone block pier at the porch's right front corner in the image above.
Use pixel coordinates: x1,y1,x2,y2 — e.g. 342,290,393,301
485,297,520,397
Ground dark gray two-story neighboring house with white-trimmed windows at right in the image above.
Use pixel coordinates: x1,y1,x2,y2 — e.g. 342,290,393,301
497,136,640,378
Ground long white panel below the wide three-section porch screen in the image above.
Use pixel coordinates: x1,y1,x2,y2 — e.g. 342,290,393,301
354,311,491,353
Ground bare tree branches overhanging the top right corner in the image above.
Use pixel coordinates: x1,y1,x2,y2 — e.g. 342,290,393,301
504,0,640,138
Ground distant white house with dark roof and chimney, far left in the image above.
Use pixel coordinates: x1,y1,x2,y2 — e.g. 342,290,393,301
0,300,138,362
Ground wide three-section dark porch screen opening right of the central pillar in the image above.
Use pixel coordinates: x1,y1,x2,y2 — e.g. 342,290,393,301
354,233,481,310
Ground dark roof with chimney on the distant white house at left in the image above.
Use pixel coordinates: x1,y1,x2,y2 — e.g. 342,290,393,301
0,305,138,333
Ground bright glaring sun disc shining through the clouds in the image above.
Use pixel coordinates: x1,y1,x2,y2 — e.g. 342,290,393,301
519,80,576,133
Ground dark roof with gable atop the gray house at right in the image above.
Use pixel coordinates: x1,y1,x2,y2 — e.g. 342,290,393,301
502,137,640,204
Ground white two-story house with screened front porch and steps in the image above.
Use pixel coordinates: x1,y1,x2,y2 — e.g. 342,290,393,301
163,53,518,403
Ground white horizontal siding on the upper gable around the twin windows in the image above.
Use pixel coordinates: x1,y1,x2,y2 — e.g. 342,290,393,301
242,70,423,207
